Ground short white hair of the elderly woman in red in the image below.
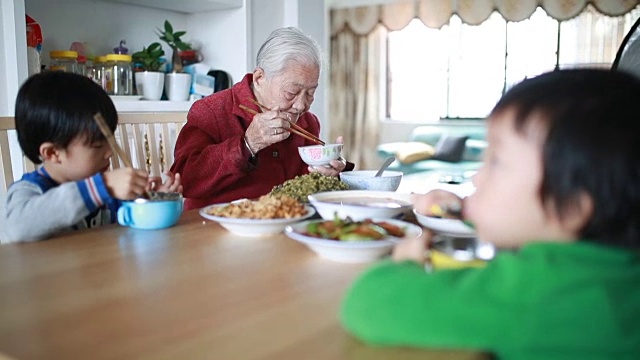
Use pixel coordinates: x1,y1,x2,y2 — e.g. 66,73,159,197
256,26,322,77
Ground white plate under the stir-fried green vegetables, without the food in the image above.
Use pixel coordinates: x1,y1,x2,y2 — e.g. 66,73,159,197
284,219,422,263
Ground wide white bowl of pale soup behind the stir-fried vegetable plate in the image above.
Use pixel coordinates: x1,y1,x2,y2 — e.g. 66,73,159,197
309,190,413,221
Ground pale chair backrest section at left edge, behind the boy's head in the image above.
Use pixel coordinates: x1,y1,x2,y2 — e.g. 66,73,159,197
0,117,35,194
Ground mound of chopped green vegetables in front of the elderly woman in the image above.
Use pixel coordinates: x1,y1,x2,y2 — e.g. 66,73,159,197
269,173,349,203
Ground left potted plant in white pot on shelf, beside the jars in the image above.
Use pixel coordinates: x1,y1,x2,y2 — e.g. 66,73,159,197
131,42,164,100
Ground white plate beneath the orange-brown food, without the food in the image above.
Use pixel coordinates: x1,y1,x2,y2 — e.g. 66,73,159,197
200,203,316,237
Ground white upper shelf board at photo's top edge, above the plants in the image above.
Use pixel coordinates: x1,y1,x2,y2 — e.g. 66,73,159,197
102,0,242,14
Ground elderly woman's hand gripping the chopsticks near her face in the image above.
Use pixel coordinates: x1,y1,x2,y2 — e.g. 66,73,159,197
244,106,291,154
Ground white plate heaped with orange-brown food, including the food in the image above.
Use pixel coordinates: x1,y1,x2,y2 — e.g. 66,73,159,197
200,196,316,236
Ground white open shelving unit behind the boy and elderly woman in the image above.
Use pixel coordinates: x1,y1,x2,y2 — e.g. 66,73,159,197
0,0,250,116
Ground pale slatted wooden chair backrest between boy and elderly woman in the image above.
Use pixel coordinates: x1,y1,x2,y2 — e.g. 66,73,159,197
111,112,187,176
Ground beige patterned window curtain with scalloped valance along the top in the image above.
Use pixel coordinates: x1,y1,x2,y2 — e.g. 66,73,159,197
329,0,640,170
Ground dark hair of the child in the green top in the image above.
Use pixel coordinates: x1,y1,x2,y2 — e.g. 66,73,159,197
492,69,640,249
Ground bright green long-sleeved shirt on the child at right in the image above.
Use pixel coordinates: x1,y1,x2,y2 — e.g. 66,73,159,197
341,242,640,360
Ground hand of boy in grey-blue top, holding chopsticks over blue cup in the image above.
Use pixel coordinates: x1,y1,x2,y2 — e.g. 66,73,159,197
102,168,149,200
